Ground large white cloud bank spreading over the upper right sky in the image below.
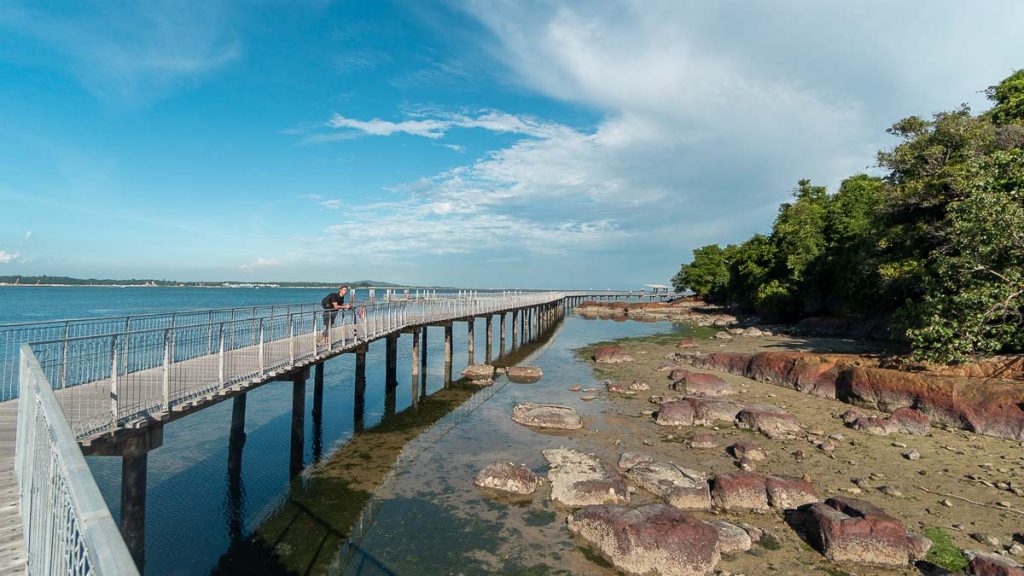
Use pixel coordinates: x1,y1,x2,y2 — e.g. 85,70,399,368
296,0,1024,282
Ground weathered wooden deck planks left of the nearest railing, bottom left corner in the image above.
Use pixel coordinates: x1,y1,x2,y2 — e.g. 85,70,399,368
0,400,28,575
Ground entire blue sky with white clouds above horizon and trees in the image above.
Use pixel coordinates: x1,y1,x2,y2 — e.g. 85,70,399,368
0,0,1024,288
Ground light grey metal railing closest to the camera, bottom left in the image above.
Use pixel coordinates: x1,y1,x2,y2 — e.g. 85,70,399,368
14,344,138,576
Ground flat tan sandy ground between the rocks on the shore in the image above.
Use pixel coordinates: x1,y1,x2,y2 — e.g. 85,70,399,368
577,327,1024,576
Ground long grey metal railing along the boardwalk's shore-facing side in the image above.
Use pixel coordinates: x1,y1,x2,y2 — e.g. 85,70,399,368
24,292,564,440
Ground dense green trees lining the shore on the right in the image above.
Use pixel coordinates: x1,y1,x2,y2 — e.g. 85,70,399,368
673,70,1024,362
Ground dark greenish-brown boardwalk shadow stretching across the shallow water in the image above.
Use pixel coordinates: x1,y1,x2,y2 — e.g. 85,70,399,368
211,315,560,576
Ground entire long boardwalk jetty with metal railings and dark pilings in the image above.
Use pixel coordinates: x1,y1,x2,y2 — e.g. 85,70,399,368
0,289,675,575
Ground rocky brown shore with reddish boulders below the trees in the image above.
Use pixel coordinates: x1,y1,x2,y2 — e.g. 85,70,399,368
468,302,1024,576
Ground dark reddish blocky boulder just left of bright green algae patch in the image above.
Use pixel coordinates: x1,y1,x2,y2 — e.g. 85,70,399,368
806,498,910,567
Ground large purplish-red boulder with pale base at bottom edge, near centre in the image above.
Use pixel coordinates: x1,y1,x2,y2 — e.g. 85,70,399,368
568,504,721,576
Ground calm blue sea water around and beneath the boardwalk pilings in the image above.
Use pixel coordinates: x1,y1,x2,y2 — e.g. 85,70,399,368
0,288,678,574
